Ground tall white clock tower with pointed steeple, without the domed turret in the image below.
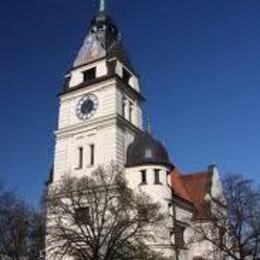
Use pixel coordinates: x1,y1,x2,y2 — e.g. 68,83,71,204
53,1,144,182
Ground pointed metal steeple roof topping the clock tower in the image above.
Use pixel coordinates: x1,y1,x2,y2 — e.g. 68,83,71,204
73,9,133,70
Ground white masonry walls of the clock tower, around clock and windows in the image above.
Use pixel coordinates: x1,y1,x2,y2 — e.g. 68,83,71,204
54,61,142,181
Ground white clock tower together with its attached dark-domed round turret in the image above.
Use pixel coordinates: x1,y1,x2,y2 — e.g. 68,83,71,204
48,0,179,256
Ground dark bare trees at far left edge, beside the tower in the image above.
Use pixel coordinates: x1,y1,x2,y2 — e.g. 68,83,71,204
0,184,45,260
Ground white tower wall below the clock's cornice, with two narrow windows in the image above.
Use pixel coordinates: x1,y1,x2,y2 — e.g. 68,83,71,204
54,123,138,181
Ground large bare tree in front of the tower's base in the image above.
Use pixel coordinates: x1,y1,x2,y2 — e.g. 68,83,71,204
46,166,171,260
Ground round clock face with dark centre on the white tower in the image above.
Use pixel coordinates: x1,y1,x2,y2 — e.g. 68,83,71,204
77,94,98,120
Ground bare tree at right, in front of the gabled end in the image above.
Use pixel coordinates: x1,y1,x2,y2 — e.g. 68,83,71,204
191,175,260,260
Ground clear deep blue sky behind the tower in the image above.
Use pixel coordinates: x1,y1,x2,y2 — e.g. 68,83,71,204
0,0,260,202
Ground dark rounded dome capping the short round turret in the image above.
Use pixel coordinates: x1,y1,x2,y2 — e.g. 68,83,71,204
126,133,173,168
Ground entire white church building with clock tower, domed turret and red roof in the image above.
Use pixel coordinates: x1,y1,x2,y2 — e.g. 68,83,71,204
46,0,223,260
